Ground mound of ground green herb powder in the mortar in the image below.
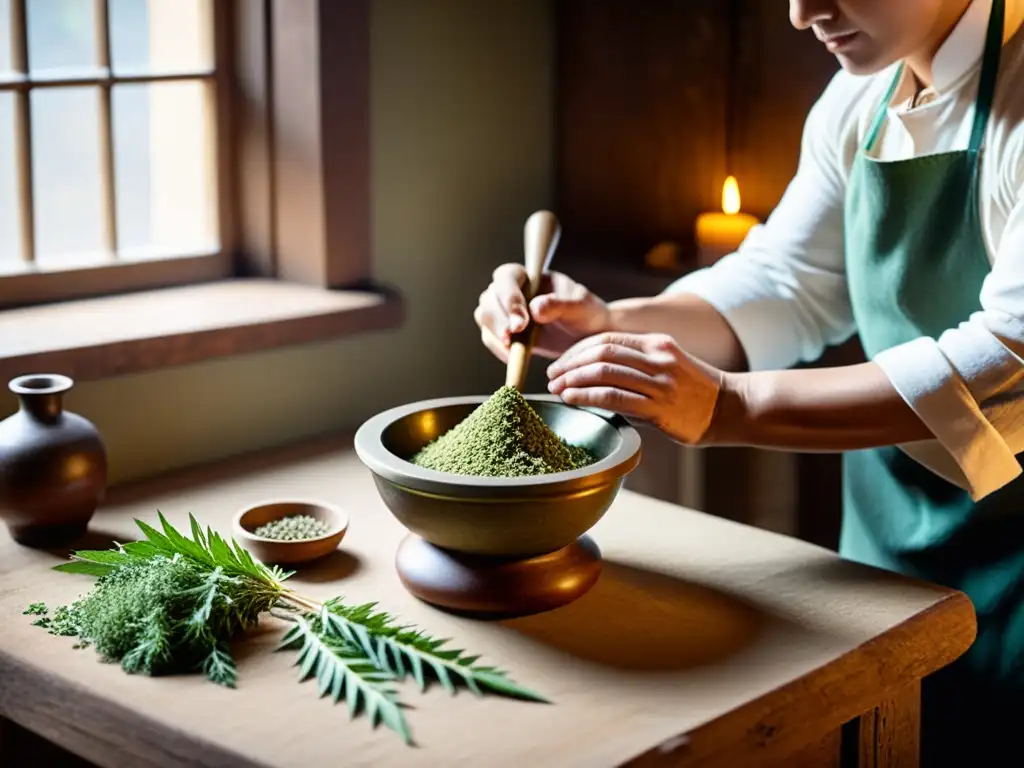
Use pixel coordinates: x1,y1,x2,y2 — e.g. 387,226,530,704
412,386,595,477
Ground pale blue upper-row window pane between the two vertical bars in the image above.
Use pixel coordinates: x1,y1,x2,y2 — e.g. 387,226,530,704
27,0,96,77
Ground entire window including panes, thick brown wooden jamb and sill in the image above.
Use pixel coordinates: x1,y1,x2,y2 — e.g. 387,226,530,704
0,0,404,383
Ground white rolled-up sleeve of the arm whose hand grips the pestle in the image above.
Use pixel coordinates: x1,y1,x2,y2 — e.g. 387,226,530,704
667,73,855,371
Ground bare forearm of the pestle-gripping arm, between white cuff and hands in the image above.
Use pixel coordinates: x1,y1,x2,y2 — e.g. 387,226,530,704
608,294,748,372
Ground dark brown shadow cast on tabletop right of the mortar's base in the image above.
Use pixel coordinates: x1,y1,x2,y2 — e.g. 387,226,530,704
502,560,771,671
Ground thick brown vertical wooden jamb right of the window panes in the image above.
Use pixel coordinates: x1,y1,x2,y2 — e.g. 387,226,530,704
233,0,373,289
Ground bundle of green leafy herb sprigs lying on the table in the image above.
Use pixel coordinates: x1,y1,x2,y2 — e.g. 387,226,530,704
25,513,547,743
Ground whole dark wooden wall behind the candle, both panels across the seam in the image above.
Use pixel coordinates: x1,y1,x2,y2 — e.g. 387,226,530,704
555,0,837,253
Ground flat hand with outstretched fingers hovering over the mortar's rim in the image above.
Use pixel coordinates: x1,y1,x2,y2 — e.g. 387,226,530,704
548,333,725,445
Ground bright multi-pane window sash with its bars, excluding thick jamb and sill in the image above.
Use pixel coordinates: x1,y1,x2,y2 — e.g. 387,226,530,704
0,0,230,306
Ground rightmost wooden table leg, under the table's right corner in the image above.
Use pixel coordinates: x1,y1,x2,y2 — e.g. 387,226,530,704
859,680,921,768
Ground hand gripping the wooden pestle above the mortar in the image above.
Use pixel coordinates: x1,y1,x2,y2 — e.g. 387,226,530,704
473,264,609,362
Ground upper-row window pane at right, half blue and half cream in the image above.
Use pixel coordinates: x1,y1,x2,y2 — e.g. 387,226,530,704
110,0,213,74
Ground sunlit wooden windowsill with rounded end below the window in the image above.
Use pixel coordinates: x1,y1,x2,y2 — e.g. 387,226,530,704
0,280,404,381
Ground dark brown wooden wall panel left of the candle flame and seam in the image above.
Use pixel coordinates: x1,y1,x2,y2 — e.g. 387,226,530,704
556,0,729,258
